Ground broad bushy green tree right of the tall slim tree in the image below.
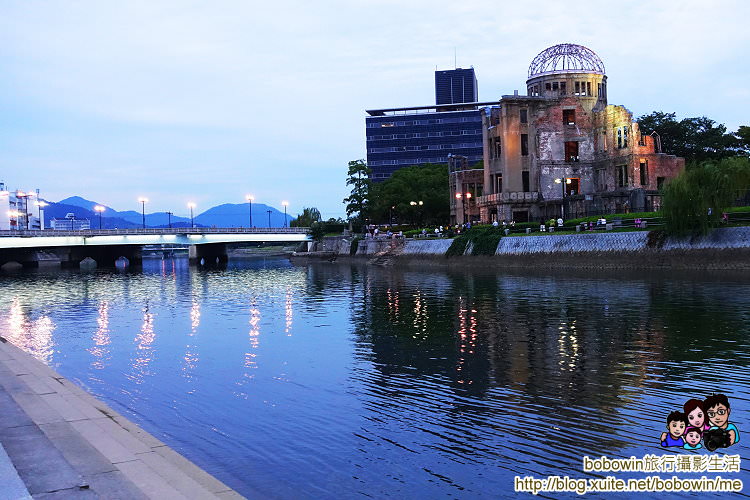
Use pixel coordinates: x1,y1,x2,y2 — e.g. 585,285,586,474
370,164,450,225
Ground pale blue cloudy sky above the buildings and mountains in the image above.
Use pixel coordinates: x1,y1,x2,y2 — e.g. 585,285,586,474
0,0,750,217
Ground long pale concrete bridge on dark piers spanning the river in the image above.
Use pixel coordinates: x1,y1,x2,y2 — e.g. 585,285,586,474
0,227,311,267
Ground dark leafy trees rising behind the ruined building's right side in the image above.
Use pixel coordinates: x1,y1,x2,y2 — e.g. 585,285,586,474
638,111,746,163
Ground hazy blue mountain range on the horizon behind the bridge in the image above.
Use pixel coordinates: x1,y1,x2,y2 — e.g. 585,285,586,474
51,196,294,229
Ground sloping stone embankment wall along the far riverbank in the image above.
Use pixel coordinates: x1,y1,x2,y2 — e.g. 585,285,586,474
302,227,750,269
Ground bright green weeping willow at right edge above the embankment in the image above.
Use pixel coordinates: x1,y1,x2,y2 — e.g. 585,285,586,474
662,157,750,236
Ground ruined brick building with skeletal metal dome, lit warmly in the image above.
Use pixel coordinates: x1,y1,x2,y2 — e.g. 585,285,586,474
476,44,685,222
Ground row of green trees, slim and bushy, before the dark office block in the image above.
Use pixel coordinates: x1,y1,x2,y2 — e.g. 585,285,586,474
344,160,450,225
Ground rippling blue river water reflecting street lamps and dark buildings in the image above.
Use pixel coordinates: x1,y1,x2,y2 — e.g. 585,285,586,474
0,259,750,499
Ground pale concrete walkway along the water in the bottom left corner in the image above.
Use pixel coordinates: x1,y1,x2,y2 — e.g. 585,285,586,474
0,337,243,500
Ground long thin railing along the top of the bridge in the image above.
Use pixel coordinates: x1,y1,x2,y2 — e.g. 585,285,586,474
0,227,310,237
